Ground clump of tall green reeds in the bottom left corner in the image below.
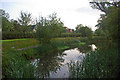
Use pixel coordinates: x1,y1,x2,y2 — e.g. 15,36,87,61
2,55,35,78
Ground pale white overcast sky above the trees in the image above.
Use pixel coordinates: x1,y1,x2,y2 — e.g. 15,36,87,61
0,0,102,30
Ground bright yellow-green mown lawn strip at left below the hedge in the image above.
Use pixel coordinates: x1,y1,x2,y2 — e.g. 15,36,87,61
2,38,38,52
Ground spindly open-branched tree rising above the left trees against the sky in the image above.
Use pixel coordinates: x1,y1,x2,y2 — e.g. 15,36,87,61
18,11,32,32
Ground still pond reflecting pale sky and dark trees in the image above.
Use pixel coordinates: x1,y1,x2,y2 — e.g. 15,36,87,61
30,44,97,78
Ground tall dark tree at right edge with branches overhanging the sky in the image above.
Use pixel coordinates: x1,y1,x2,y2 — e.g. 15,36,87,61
90,1,120,41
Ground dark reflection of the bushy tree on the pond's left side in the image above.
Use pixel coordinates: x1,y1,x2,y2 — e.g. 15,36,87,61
32,52,64,78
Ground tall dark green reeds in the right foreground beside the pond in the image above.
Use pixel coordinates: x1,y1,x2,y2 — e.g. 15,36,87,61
69,44,119,78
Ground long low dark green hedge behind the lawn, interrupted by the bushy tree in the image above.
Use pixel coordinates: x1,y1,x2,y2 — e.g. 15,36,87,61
2,32,81,40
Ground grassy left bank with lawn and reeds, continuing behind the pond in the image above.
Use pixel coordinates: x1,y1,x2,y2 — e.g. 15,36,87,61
2,38,88,78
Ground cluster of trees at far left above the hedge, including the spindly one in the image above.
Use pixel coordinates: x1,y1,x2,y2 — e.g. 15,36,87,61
0,9,32,33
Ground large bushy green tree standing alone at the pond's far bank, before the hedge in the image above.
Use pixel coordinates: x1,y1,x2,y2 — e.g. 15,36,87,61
36,13,63,44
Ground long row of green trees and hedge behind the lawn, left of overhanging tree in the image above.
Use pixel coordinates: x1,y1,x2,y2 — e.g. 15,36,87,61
0,9,92,39
